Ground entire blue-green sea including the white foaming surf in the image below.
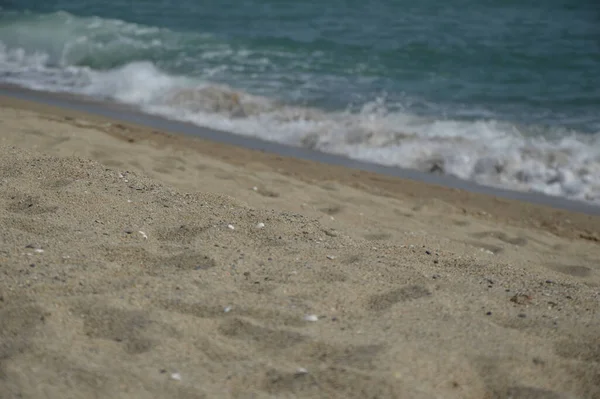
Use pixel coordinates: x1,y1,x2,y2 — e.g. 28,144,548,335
0,0,600,203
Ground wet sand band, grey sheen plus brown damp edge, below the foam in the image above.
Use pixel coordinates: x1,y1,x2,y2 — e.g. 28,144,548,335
0,87,600,243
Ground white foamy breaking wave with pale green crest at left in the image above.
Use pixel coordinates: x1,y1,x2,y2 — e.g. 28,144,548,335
0,13,600,203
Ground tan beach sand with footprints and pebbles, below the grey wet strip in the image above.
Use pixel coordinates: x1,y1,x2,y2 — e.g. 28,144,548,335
0,98,600,399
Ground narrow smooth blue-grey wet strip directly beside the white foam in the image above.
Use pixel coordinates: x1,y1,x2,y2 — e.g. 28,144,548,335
0,85,600,219
